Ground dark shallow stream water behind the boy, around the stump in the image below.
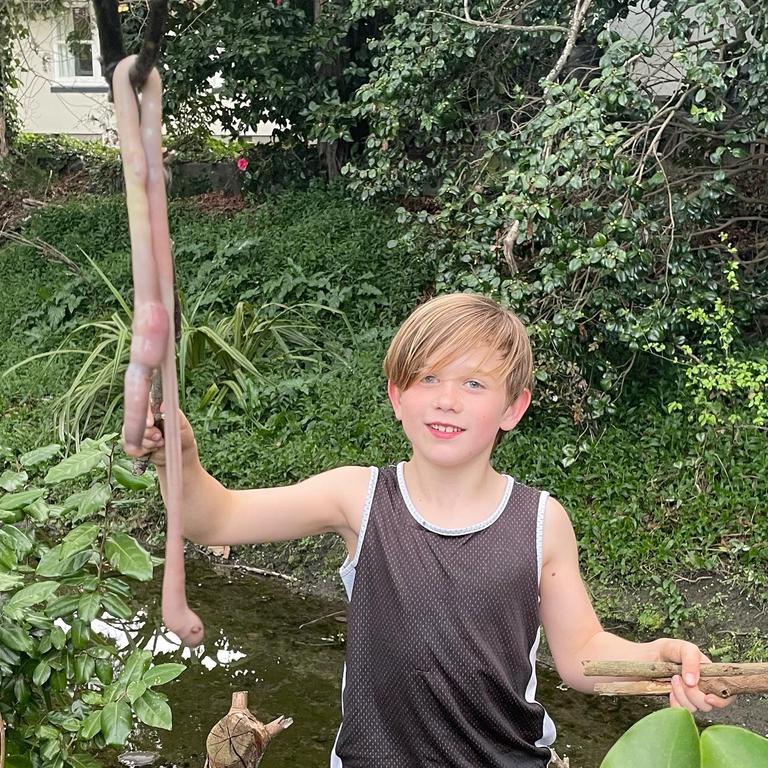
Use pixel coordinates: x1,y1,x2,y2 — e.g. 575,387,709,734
103,560,680,768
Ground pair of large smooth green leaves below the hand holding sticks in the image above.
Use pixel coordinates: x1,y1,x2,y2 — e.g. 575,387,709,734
600,708,768,768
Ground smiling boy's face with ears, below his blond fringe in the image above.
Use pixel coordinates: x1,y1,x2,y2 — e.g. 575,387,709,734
388,348,530,466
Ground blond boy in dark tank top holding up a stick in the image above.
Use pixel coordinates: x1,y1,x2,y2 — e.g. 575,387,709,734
130,294,728,768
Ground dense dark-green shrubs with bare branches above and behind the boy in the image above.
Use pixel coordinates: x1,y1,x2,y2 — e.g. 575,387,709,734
152,0,768,421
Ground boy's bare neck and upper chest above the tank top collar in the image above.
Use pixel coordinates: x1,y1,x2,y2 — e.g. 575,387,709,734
403,456,506,528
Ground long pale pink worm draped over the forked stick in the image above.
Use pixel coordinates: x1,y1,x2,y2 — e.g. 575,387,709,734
112,56,203,647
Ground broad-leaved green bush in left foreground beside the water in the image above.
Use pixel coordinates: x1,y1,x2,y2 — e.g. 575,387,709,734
0,435,184,768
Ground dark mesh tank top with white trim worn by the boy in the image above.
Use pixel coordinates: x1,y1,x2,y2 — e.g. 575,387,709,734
331,464,555,768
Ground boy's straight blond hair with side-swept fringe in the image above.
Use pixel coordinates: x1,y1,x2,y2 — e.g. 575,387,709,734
384,293,533,403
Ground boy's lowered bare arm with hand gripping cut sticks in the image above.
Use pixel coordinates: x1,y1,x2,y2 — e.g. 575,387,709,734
539,498,730,712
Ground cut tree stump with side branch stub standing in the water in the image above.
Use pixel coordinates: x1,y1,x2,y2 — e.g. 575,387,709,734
205,691,293,768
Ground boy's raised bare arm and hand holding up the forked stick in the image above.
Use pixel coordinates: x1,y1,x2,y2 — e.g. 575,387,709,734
124,414,370,551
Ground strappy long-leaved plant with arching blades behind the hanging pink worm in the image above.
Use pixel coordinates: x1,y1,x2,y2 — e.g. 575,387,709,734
3,252,349,445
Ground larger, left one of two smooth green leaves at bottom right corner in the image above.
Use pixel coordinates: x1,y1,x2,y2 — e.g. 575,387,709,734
600,708,700,768
